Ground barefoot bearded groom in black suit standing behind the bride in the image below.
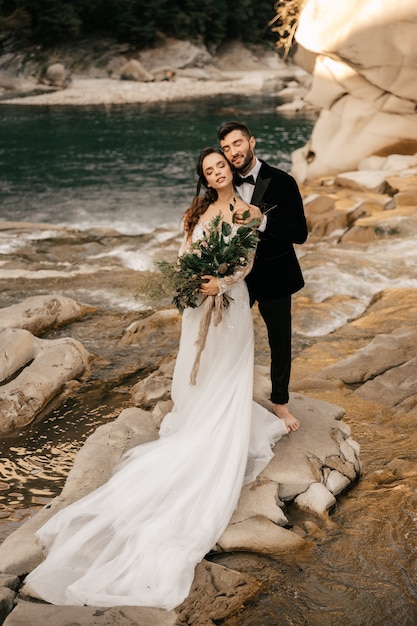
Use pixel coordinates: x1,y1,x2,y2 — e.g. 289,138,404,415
218,122,307,431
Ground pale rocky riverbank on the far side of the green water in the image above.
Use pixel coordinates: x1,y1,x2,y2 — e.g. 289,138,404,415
0,40,310,106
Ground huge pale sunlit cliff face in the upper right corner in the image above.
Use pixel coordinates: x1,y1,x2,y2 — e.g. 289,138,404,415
293,0,417,181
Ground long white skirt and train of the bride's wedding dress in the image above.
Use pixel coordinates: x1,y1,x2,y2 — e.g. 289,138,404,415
26,227,287,609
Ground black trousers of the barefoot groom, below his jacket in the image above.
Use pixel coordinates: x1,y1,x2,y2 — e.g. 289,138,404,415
252,295,291,404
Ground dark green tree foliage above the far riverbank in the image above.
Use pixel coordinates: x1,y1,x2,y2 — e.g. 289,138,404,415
0,0,282,48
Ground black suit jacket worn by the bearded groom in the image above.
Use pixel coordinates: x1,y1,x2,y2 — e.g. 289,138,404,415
246,161,308,300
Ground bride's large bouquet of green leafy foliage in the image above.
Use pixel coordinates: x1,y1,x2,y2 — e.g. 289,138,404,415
157,211,258,312
